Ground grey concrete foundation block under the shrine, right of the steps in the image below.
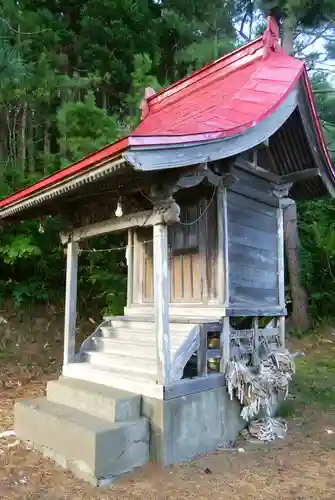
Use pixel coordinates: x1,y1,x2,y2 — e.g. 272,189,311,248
142,386,246,465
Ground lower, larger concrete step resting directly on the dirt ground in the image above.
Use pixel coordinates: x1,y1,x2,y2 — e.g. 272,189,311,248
15,398,149,485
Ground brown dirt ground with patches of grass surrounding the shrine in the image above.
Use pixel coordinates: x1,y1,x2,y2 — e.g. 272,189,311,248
0,310,335,500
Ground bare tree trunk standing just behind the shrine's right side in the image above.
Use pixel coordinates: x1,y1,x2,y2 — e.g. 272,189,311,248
284,203,311,331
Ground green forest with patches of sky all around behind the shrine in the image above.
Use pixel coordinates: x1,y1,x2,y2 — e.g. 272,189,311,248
0,0,335,321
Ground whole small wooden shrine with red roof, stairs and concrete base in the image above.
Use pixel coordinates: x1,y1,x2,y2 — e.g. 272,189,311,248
0,18,335,484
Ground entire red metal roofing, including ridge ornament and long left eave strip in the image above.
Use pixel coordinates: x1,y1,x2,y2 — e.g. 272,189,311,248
0,18,330,209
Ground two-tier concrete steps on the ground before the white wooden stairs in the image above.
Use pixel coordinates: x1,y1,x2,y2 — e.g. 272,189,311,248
15,377,149,486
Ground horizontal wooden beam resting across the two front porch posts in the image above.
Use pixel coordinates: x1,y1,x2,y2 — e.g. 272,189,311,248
60,210,168,245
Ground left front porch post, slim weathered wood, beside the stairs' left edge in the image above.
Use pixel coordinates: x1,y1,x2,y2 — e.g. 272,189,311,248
63,241,79,365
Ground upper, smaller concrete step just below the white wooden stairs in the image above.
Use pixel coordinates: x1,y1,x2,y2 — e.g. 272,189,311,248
47,377,141,422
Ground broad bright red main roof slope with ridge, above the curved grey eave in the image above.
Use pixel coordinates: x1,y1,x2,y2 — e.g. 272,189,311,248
130,39,304,145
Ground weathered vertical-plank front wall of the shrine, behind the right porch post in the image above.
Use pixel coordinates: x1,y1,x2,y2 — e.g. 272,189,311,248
133,198,218,304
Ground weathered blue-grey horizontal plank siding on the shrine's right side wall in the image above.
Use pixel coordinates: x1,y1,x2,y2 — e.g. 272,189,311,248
227,171,278,307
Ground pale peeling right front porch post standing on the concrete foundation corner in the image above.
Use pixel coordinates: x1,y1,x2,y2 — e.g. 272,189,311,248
153,224,171,386
